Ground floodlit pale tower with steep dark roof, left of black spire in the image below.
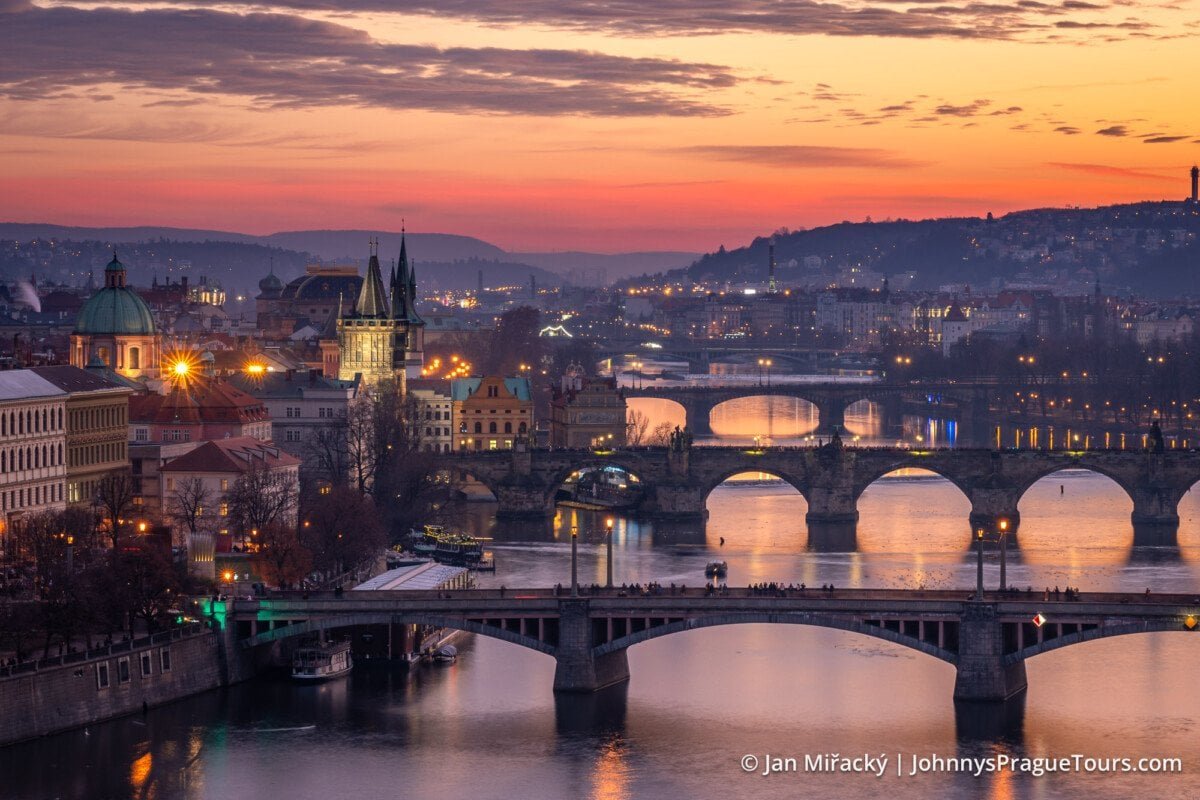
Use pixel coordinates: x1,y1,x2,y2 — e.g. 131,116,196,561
336,240,404,391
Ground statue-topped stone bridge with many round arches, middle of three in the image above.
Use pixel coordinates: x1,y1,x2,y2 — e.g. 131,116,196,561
439,445,1200,545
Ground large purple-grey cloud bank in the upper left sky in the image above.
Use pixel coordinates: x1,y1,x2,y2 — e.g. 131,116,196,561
0,0,738,116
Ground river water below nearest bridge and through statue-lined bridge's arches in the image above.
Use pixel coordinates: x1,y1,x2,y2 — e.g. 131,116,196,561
0,473,1200,800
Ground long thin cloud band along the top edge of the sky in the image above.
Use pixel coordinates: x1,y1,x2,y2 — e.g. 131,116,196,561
56,0,1171,41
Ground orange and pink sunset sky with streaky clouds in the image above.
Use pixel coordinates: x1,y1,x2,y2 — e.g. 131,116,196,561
0,0,1200,252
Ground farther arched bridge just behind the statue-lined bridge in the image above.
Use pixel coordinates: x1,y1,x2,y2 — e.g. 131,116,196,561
624,381,998,441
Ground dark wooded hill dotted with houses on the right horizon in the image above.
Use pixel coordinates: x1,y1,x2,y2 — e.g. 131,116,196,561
677,201,1200,296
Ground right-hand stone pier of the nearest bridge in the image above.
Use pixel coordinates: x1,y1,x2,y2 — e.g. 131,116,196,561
954,601,1028,702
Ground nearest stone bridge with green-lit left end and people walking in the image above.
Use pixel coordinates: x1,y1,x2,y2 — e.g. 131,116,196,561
216,588,1200,700
